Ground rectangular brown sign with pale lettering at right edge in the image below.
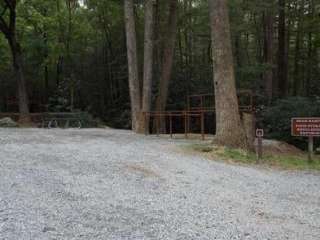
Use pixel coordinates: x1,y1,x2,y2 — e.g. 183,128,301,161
291,118,320,137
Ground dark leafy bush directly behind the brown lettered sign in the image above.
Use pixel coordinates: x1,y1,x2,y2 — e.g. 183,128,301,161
258,97,320,149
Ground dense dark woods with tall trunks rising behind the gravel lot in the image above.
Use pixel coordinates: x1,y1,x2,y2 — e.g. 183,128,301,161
0,0,320,148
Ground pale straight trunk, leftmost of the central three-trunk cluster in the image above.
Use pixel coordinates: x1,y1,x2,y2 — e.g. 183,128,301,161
124,0,141,132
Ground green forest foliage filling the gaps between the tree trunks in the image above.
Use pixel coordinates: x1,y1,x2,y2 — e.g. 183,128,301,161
0,0,320,131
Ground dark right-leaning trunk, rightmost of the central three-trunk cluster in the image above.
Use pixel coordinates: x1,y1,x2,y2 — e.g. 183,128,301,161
156,0,178,130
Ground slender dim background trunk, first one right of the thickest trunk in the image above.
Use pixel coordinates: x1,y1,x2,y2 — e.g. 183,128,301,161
263,10,274,104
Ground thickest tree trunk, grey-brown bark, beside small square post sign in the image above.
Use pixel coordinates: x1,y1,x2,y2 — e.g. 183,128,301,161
209,0,248,149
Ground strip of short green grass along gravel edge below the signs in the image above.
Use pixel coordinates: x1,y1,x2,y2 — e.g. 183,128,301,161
187,144,320,171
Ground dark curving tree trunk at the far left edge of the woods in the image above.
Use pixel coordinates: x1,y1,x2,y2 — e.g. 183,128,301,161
0,0,30,123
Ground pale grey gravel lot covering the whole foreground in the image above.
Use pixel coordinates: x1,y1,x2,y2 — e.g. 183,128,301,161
0,129,320,240
